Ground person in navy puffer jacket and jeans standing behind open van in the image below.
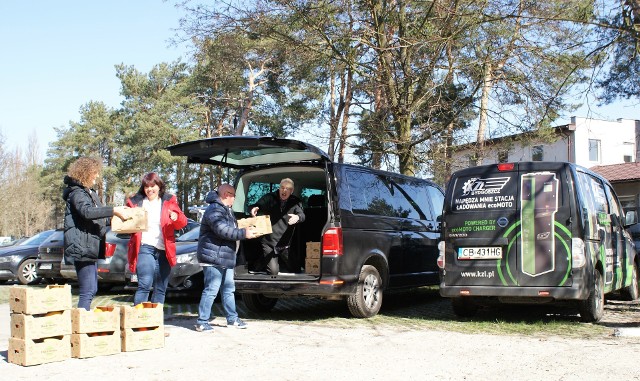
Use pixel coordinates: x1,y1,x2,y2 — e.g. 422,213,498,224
196,184,256,332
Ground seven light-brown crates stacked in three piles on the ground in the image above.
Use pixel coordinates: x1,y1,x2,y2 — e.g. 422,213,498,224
7,285,164,366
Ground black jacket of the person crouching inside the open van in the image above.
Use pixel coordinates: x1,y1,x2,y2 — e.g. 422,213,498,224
249,190,304,254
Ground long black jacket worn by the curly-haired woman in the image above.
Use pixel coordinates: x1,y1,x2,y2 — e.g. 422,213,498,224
62,176,113,265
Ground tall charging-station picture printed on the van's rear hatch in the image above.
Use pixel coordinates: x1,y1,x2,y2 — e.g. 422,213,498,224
520,172,558,277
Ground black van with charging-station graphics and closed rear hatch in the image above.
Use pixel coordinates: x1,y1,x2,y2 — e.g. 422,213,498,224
438,162,639,322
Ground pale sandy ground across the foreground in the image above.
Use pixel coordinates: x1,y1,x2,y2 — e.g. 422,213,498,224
0,304,640,381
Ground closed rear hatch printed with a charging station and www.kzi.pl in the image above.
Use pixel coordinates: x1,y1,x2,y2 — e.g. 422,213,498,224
444,162,573,287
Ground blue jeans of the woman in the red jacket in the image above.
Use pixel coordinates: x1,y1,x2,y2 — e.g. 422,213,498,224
133,245,171,305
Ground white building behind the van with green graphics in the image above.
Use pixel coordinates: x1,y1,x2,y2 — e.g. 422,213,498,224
452,116,640,171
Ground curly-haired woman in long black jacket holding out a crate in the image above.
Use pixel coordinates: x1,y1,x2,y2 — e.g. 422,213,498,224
62,157,128,310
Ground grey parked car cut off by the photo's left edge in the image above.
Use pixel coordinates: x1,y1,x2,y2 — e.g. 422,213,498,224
0,230,55,284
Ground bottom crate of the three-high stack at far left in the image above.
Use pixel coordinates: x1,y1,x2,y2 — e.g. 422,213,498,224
7,335,71,366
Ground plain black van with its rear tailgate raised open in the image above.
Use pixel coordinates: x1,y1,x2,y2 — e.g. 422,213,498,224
168,136,444,317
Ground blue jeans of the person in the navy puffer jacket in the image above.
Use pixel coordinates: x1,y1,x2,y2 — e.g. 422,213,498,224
198,266,238,324
